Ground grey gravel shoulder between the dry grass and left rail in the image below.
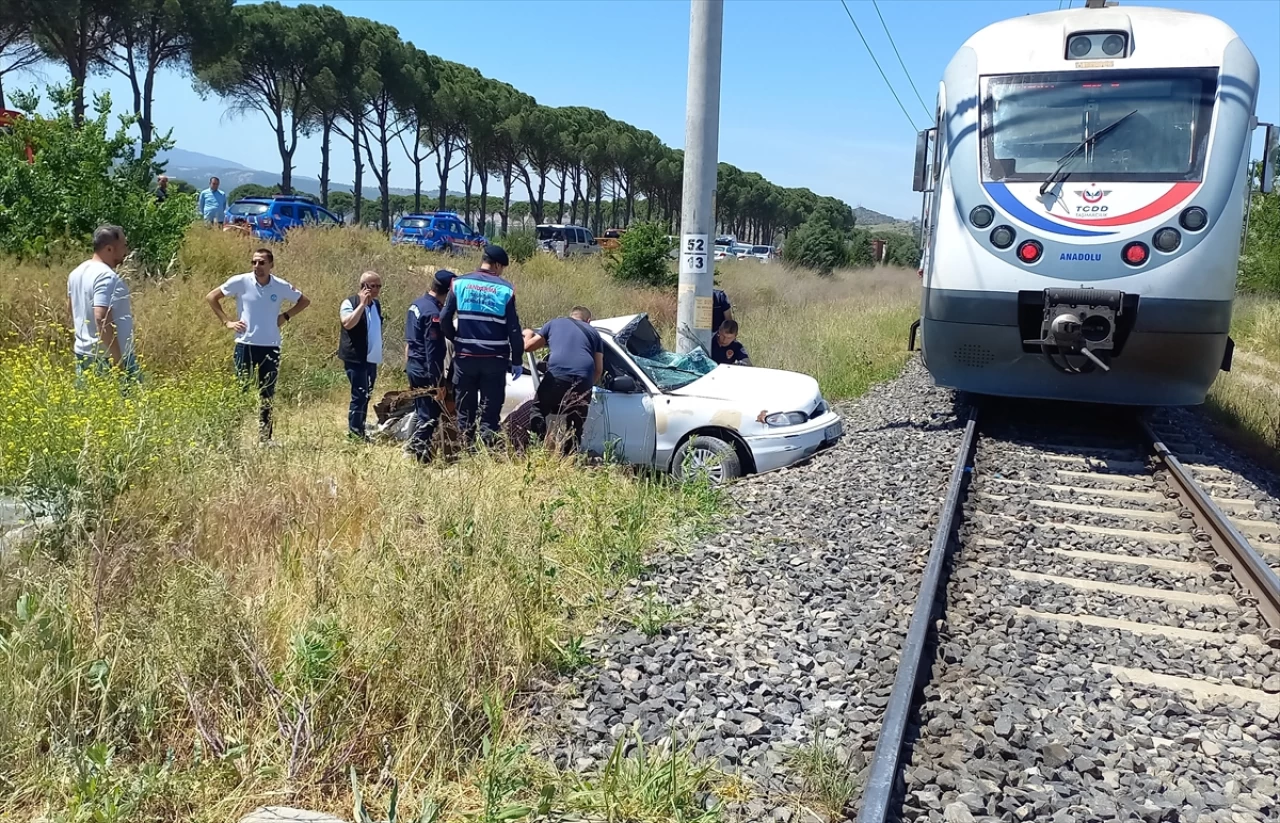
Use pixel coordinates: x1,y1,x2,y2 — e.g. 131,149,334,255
531,361,961,820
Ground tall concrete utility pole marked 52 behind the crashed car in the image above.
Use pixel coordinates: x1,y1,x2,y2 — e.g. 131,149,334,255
676,0,724,353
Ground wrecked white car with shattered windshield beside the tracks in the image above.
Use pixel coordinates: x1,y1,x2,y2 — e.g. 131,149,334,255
373,314,844,484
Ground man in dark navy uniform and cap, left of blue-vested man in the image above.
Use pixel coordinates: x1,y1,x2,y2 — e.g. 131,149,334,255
404,269,454,461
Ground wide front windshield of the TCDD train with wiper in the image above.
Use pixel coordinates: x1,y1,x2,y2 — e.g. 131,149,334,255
982,69,1217,183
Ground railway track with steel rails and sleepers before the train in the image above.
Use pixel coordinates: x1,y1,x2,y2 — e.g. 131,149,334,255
858,410,1280,823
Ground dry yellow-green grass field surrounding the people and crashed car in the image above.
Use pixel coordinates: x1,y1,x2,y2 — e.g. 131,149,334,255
0,227,916,823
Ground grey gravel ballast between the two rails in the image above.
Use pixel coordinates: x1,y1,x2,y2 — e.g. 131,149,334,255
904,412,1280,823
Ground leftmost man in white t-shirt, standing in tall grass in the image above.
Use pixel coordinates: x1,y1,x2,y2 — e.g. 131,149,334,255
67,225,138,376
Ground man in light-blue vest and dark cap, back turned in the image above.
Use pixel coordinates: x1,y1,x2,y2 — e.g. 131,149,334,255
440,246,525,443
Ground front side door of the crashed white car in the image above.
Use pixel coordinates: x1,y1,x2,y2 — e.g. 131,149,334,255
582,339,658,466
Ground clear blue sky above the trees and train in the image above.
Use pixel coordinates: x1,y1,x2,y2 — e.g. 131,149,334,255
13,0,1280,218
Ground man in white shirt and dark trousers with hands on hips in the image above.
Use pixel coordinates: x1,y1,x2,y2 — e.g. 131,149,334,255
205,248,311,443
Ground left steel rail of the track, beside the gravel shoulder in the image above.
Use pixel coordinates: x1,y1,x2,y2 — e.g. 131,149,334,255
858,407,978,823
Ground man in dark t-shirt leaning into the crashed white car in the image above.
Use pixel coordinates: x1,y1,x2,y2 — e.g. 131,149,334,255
525,306,604,453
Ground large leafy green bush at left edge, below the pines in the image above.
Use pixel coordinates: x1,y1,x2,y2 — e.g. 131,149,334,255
0,87,196,273
